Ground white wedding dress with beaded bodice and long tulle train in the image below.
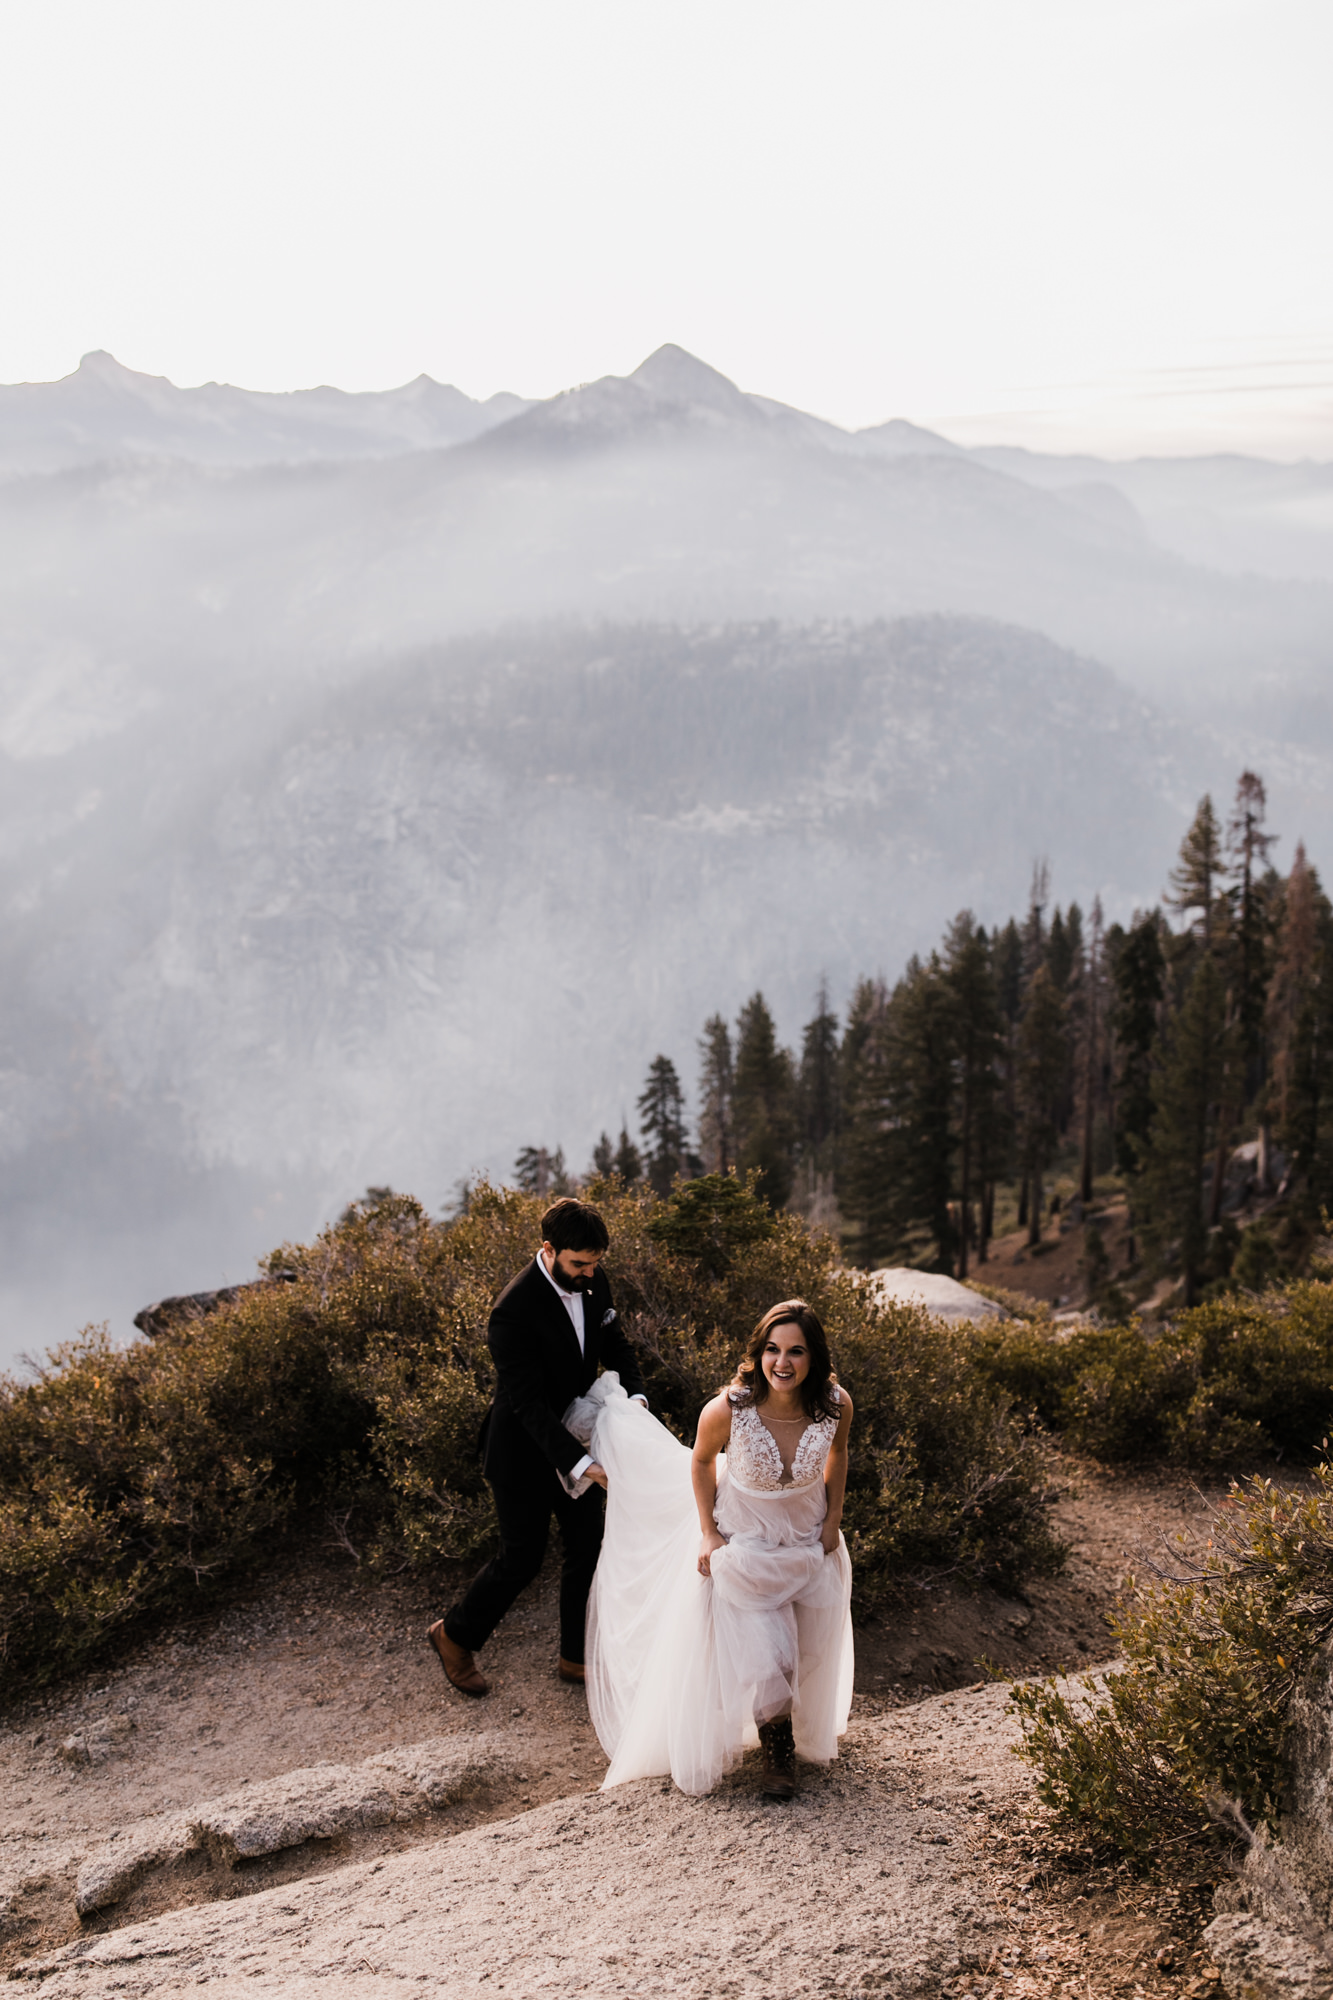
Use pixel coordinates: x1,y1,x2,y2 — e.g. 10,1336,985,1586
564,1372,853,1792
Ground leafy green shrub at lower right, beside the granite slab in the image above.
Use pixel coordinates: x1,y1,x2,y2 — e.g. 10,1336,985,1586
1013,1464,1333,1862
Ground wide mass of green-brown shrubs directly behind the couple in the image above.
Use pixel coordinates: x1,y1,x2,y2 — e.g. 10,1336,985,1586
0,1180,1059,1688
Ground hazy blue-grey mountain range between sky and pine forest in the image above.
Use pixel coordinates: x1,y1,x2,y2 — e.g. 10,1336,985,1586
0,348,1333,1354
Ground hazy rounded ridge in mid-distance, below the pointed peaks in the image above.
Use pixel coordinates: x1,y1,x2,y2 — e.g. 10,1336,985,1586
0,618,1184,1358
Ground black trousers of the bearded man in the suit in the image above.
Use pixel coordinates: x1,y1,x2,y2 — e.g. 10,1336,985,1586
444,1470,602,1664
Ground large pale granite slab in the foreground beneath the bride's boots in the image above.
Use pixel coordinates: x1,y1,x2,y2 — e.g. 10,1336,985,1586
16,1752,996,2000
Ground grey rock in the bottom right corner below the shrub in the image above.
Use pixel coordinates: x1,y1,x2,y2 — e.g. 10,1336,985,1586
1205,1646,1333,2000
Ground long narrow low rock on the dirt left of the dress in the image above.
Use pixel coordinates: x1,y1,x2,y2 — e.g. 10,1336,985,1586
74,1736,512,1916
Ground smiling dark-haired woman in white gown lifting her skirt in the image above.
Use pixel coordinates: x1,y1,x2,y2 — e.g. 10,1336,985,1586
564,1298,853,1798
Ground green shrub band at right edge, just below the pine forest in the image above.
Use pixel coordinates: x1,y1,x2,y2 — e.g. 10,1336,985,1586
975,1280,1333,1464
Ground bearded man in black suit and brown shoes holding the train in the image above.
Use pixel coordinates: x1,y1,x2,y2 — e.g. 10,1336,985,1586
426,1196,646,1694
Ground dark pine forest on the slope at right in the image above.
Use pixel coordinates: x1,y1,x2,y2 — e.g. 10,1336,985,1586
536,772,1333,1310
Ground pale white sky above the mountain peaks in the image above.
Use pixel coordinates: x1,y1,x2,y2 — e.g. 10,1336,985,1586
0,0,1333,458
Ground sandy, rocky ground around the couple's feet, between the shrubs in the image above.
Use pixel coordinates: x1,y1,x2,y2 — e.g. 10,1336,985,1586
0,1466,1248,2000
